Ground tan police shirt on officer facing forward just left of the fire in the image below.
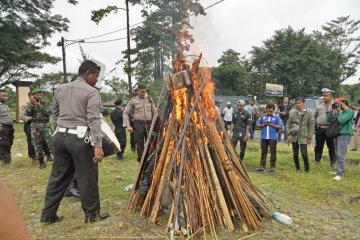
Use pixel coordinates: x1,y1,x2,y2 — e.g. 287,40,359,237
123,96,155,127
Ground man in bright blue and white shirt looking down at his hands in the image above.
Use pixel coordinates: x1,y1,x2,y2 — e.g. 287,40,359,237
256,104,283,172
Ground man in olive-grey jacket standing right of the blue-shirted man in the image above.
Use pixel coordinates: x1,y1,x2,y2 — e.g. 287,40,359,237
287,97,314,173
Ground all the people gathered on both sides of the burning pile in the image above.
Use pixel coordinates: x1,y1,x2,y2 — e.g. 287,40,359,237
0,60,360,234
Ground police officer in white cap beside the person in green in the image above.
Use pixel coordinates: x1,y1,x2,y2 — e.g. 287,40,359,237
314,88,336,166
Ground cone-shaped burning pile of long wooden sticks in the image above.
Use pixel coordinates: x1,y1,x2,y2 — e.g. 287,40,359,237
129,56,270,238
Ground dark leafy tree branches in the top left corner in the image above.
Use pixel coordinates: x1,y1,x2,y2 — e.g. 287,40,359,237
0,0,77,86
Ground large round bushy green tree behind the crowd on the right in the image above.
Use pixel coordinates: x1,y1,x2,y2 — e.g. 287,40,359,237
250,27,346,97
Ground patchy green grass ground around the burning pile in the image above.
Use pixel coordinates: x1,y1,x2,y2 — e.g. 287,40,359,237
0,124,360,239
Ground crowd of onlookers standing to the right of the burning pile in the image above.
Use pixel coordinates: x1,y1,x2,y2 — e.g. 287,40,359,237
222,88,360,180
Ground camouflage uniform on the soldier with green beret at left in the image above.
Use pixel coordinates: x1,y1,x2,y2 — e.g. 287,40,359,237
25,101,52,164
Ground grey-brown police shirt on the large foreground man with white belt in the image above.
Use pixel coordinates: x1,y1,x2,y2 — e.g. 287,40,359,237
53,77,102,147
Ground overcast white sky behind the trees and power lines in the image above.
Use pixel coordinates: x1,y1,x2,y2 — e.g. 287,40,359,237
37,0,360,84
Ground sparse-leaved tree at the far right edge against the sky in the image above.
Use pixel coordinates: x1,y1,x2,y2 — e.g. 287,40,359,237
314,16,360,82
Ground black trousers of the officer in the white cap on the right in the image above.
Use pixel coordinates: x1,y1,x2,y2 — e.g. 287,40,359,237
314,127,336,165
